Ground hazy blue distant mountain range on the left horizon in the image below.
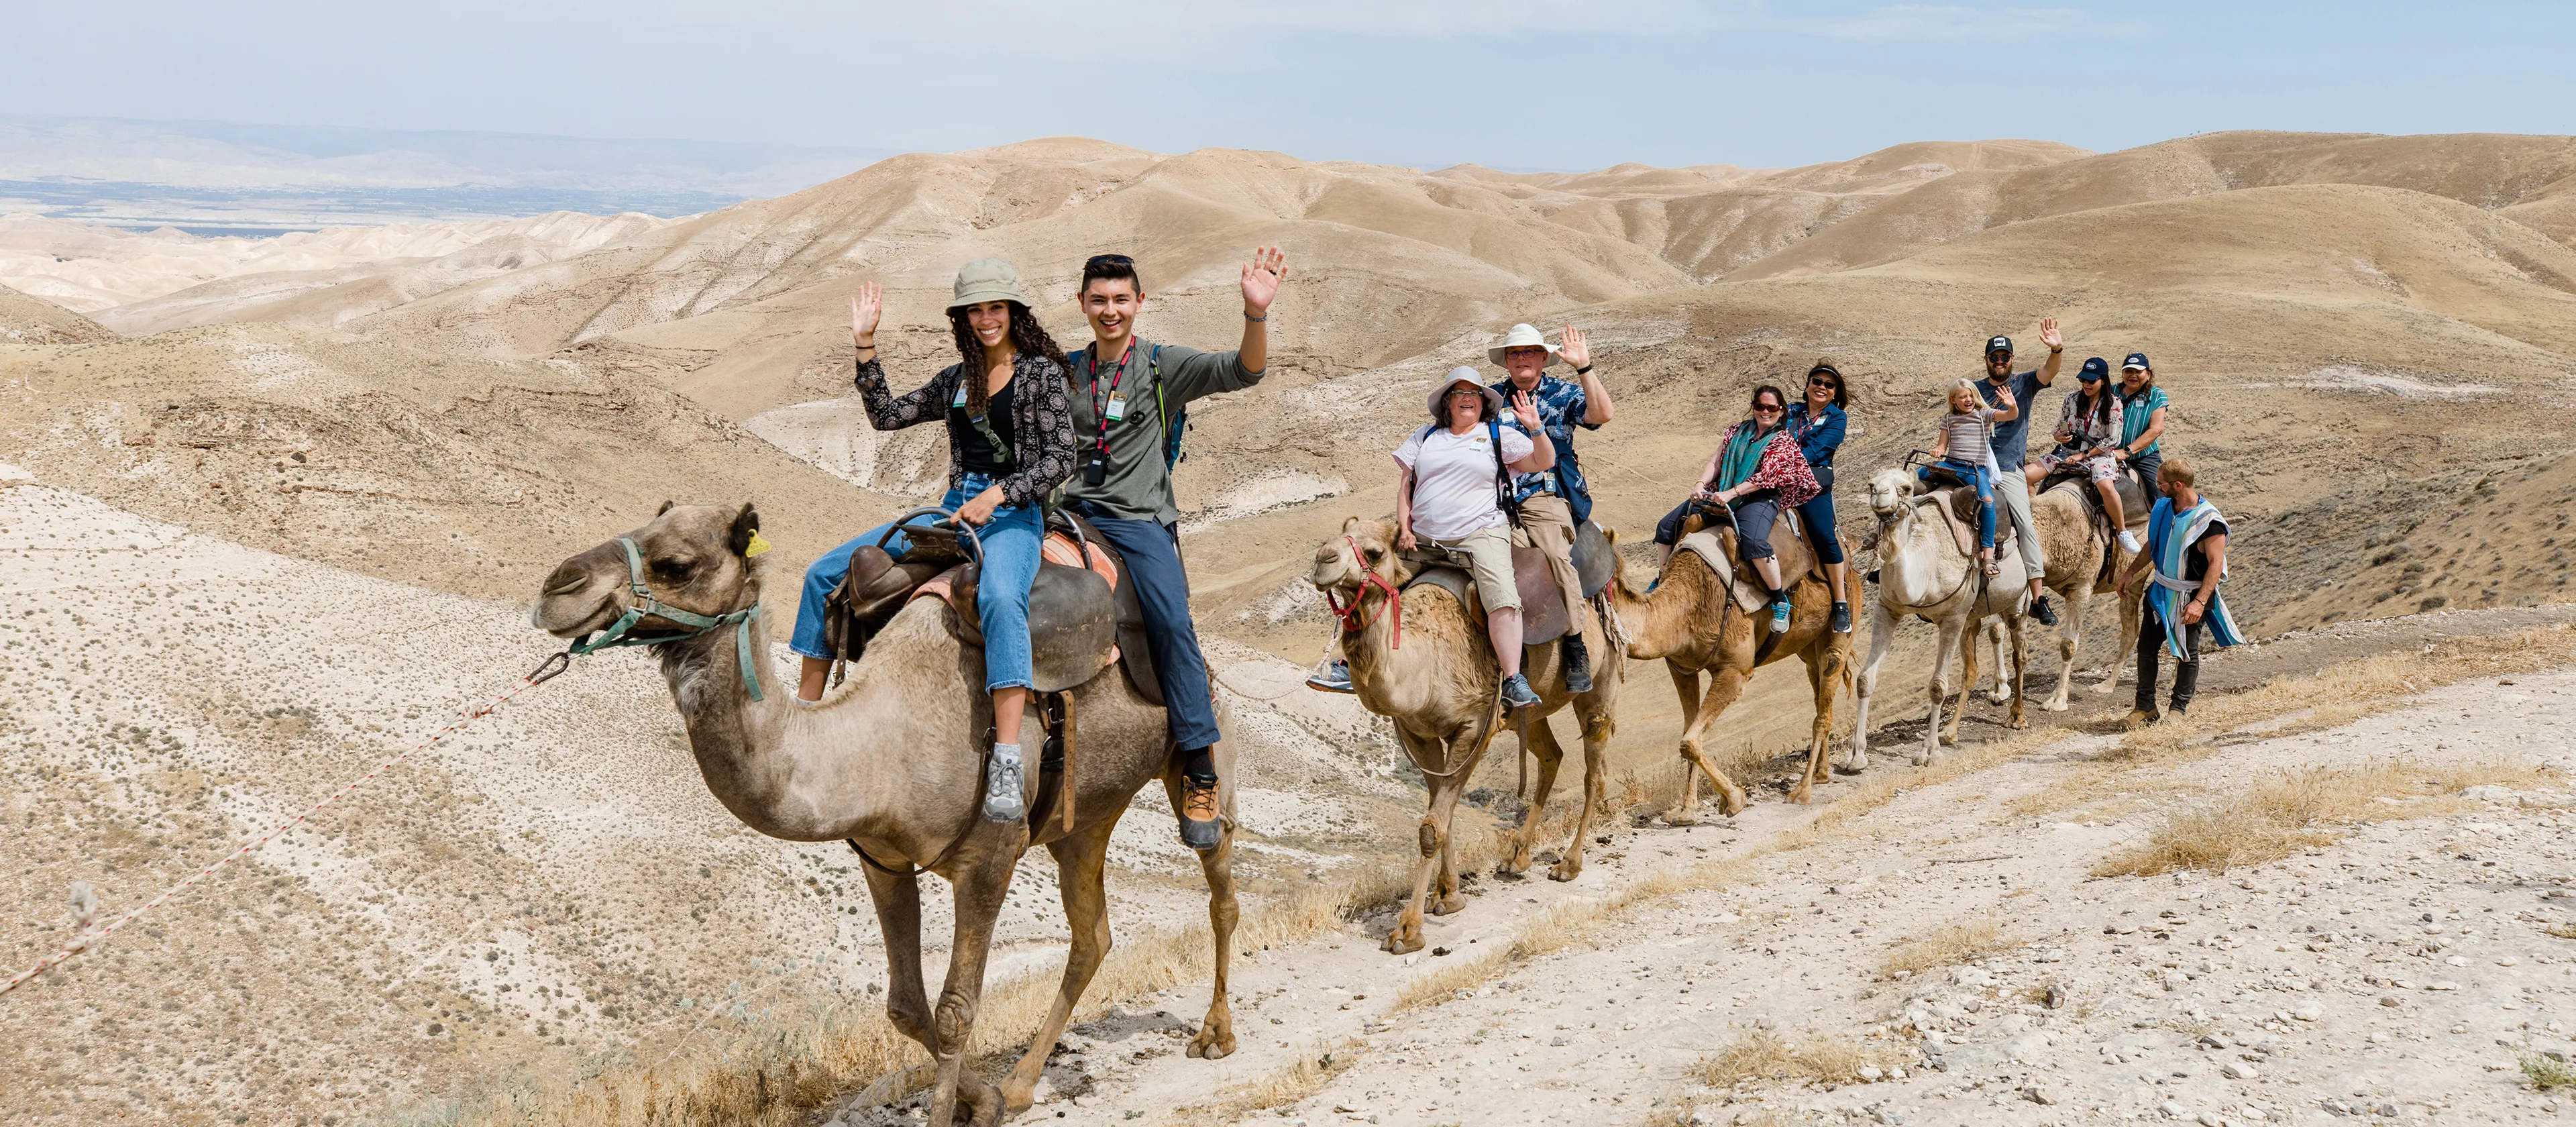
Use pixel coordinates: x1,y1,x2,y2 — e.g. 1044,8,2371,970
0,113,894,234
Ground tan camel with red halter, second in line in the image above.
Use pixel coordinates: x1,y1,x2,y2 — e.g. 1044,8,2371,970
1309,517,1625,955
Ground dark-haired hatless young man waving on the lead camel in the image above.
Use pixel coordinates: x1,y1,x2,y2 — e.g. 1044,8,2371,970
1064,247,1288,852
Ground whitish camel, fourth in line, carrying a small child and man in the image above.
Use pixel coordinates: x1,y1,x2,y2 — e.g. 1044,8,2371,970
1842,466,2030,775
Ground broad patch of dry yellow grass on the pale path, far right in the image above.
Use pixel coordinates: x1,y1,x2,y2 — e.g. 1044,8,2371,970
2094,759,2558,877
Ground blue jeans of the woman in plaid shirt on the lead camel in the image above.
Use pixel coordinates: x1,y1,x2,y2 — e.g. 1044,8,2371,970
788,474,1046,692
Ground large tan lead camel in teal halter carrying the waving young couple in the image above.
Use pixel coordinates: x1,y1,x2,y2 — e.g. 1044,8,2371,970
533,504,1236,1127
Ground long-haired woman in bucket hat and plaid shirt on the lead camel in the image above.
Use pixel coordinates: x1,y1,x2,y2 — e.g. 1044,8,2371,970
788,258,1074,821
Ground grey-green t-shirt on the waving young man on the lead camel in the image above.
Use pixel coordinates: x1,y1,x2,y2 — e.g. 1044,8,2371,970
1064,337,1263,525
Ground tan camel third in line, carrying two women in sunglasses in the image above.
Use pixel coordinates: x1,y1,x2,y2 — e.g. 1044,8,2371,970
1610,527,1852,826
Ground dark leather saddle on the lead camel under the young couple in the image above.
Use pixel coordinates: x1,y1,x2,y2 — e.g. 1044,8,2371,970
824,512,1162,705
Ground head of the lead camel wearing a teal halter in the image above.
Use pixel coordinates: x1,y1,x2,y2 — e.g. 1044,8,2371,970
528,502,767,638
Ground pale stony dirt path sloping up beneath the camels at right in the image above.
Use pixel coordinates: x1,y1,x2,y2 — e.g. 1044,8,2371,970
819,612,2576,1124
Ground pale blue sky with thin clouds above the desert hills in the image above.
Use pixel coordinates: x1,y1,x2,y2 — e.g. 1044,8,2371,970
0,0,2576,170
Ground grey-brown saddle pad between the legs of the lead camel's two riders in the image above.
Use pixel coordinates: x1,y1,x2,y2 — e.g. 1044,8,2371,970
912,533,1118,692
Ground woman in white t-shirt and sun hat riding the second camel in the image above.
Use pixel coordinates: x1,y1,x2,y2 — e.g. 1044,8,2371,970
1396,368,1556,708
